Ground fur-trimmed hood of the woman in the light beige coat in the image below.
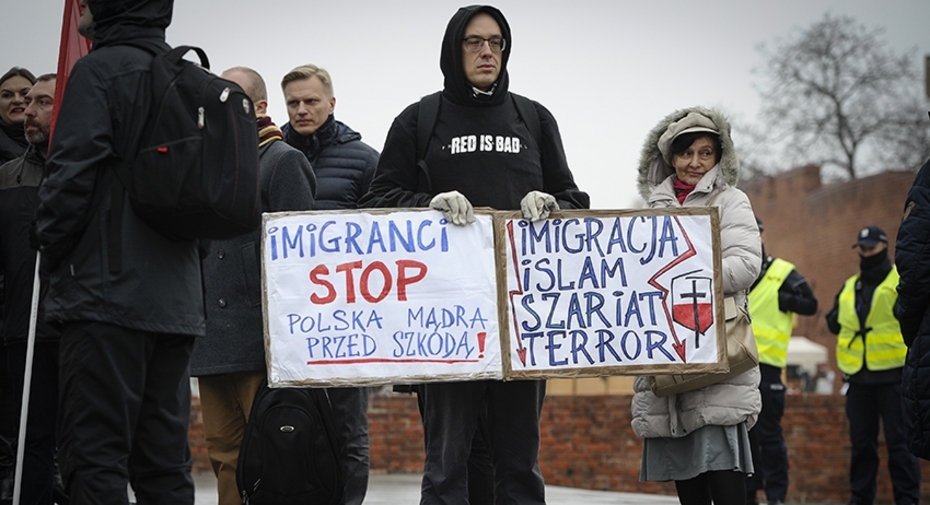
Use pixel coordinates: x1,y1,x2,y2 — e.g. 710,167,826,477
636,107,739,201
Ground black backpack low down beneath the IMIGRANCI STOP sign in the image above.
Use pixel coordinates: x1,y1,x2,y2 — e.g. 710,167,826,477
236,384,345,505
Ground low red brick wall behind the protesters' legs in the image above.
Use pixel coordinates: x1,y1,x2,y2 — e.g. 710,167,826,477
191,394,930,504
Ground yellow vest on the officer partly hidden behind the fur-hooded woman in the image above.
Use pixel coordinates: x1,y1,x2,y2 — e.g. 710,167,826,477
749,258,794,368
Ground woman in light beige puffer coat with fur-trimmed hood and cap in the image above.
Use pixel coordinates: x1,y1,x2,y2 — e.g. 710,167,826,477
632,107,762,505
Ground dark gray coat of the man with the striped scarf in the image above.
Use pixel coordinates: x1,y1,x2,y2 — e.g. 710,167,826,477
191,136,316,376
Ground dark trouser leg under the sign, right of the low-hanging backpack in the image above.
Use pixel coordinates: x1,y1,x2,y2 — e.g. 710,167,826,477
326,388,370,505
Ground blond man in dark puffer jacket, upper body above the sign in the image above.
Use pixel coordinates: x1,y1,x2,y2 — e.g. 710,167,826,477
281,65,378,210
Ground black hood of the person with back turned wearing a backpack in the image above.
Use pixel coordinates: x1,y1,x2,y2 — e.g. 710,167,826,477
86,0,174,49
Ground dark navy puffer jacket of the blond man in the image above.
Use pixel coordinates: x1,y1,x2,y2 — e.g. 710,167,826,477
281,116,378,210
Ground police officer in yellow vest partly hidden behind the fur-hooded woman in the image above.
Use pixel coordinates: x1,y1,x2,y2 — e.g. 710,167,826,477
746,217,817,505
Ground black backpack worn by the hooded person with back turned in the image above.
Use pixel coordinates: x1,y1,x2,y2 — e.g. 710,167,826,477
117,42,261,240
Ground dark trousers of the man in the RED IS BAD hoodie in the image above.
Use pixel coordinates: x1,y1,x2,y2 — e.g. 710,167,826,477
420,381,546,505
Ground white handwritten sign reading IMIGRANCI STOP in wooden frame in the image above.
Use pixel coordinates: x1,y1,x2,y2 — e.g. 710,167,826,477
261,208,502,387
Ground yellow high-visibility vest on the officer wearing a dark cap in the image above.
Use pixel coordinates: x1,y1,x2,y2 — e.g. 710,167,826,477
836,266,907,375
